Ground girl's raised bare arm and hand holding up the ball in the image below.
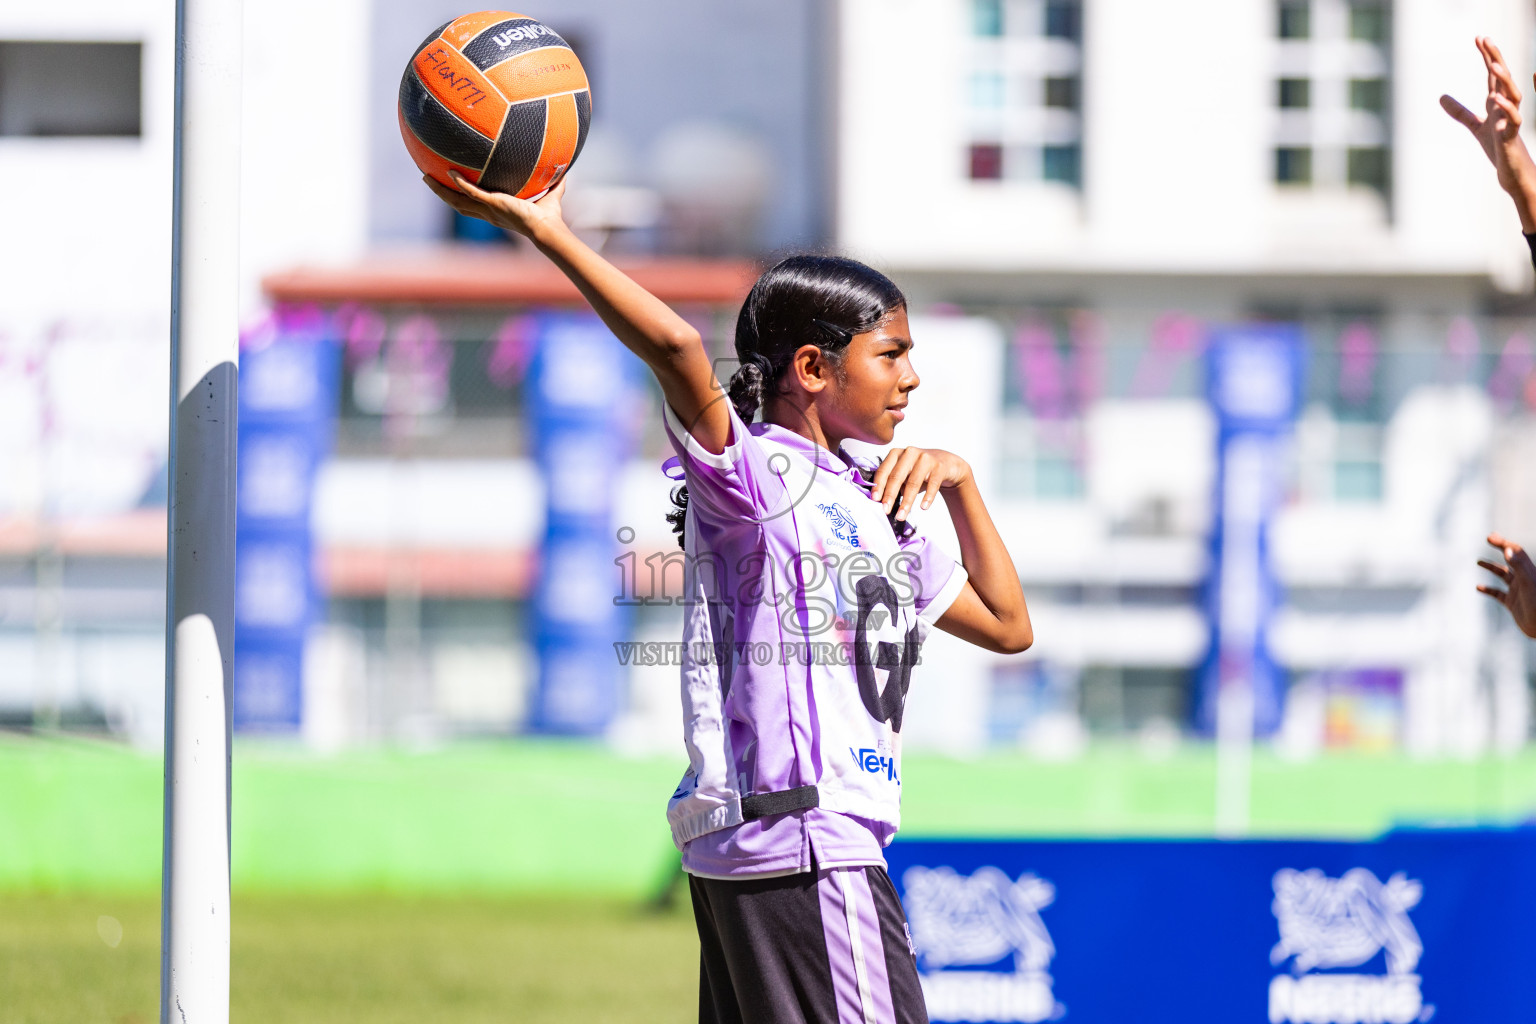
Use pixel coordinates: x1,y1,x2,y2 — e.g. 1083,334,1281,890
422,172,733,454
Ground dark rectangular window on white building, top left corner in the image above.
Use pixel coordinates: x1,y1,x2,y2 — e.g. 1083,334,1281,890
0,40,143,138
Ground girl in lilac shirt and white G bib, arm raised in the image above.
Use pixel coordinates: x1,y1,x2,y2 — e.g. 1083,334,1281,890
427,177,1034,1024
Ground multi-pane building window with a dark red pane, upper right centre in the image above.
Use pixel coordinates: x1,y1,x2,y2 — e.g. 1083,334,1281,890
966,0,1083,189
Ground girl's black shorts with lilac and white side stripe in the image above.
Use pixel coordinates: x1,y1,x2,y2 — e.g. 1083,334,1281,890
688,867,928,1024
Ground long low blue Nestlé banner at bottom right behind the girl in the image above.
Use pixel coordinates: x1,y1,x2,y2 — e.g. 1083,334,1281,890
886,829,1536,1024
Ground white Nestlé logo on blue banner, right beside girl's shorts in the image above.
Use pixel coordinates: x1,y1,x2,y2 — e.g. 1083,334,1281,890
902,867,1066,1024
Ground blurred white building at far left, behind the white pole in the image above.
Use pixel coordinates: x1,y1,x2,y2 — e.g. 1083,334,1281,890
0,0,369,748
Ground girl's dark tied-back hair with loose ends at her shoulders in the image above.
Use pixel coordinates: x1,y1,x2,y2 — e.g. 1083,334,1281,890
667,255,912,547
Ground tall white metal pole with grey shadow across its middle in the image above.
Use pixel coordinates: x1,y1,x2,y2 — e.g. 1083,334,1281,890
160,0,241,1024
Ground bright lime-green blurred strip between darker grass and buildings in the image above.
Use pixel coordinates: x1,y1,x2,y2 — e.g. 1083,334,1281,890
0,727,1536,900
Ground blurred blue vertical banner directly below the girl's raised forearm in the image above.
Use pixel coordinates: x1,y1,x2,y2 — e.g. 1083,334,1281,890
528,313,634,735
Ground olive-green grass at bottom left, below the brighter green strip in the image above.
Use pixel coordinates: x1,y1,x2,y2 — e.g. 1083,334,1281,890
0,894,699,1024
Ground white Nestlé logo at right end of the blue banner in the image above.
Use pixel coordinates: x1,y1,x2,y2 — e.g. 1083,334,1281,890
1269,867,1435,1024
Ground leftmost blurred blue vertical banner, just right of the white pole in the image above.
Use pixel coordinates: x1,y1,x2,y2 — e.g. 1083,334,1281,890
233,309,339,734
